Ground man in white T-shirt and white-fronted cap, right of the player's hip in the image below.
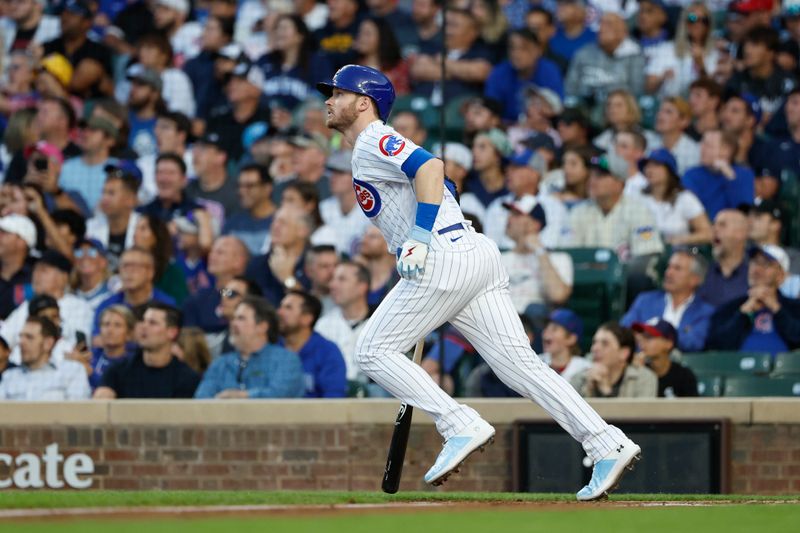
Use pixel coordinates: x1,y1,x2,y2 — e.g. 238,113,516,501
501,195,573,316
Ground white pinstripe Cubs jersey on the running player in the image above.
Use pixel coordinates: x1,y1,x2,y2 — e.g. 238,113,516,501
352,120,466,253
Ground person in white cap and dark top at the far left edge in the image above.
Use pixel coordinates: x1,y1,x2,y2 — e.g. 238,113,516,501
0,214,38,320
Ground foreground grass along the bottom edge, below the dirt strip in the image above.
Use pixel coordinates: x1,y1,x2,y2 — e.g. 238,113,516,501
0,505,800,533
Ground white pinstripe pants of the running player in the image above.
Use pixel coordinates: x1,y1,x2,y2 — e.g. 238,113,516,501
355,229,625,461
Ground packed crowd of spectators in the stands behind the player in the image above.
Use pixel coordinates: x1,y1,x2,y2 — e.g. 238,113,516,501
0,0,800,400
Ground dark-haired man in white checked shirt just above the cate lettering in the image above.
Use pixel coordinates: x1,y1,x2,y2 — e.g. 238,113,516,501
0,317,91,401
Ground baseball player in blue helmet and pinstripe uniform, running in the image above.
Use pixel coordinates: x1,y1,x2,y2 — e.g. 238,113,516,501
317,65,641,500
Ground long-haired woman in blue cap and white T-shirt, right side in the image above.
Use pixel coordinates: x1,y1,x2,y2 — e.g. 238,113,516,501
639,148,712,245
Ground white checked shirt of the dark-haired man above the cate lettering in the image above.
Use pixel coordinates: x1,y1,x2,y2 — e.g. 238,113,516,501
0,361,91,401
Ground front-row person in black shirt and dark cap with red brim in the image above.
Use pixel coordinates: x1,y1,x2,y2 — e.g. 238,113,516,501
631,318,697,398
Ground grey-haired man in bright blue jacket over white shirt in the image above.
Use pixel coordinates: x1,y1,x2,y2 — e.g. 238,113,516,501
620,250,714,352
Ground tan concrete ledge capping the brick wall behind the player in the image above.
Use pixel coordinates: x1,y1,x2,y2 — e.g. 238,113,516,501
0,398,800,426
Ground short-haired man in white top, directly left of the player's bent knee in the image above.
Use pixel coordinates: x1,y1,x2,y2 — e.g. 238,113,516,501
314,261,370,381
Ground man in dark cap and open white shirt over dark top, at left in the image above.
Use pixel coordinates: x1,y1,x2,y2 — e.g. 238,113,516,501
0,250,94,363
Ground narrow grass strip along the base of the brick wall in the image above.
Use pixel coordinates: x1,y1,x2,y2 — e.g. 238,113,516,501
0,490,800,509
